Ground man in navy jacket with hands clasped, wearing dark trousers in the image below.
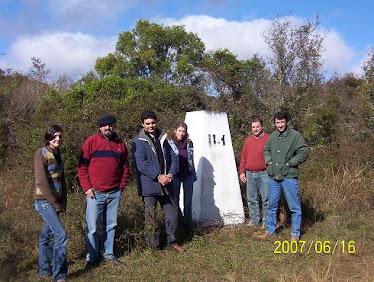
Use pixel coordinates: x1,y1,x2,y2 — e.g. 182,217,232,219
132,111,184,252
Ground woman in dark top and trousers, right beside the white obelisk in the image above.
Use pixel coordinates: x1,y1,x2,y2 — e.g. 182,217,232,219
169,122,197,233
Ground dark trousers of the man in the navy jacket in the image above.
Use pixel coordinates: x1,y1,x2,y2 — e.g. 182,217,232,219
143,194,178,249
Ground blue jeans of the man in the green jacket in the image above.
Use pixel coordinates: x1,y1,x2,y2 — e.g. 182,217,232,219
266,178,301,236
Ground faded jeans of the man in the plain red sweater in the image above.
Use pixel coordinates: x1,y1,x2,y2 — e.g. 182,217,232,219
246,171,269,225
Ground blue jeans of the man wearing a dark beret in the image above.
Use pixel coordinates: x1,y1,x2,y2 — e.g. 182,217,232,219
86,189,122,263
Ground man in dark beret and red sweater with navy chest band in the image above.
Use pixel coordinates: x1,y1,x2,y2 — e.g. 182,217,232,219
78,114,129,269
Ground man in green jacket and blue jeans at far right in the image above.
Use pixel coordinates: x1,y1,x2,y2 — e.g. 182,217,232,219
260,112,309,241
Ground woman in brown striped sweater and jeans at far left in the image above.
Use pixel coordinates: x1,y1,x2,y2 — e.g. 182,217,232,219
34,125,67,282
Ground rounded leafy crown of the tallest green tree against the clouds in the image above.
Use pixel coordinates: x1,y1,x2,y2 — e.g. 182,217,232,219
95,20,204,85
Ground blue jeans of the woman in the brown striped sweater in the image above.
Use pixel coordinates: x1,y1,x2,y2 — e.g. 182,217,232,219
34,200,68,280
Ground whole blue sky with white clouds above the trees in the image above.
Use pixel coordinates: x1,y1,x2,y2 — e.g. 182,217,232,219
0,0,374,79
